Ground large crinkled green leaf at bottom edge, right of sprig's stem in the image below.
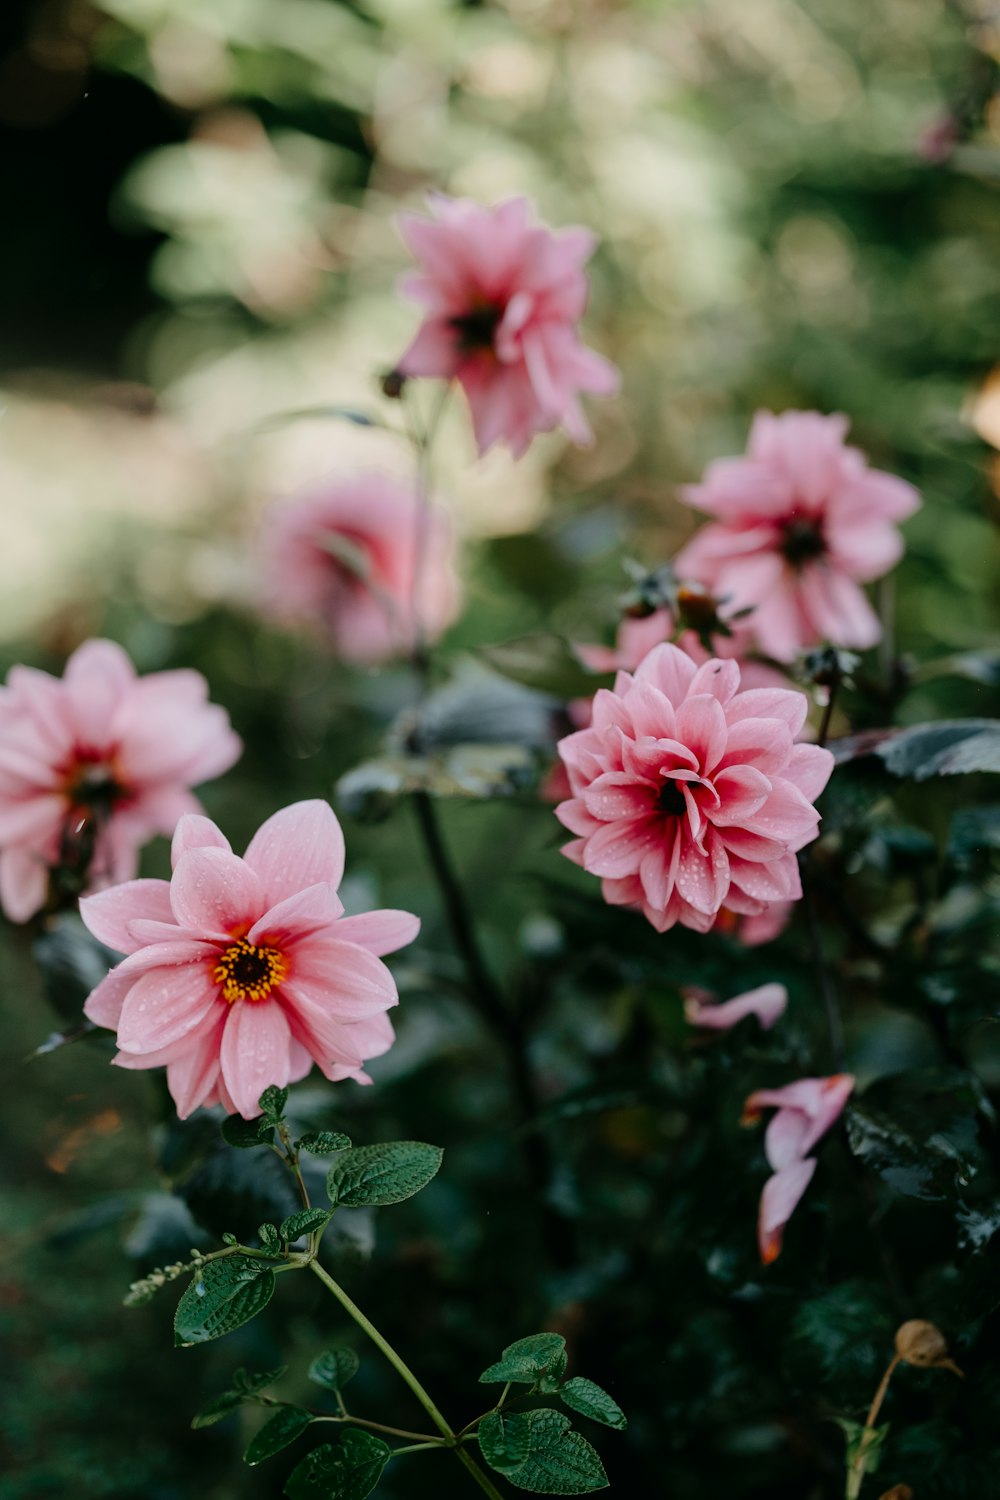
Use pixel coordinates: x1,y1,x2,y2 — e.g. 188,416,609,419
480,1410,607,1496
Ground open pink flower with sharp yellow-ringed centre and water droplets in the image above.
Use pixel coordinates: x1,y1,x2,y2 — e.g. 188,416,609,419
81,801,420,1119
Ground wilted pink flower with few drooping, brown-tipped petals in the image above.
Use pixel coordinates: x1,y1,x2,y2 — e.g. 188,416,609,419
744,1073,855,1266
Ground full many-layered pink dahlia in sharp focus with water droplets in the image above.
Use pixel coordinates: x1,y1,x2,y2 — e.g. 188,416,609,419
556,645,834,932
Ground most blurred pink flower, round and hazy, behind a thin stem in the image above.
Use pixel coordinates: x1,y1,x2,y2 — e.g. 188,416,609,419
259,471,459,662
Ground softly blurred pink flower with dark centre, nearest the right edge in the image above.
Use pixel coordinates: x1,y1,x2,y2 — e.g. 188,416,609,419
676,411,921,662
